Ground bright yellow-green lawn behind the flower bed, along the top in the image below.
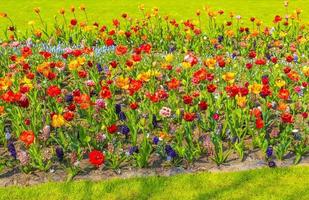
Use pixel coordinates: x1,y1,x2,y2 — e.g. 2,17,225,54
0,0,309,35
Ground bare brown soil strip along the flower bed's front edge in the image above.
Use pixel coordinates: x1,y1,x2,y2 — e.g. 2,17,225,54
0,151,309,187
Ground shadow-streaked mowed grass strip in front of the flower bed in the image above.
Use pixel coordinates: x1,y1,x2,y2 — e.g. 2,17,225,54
0,167,309,200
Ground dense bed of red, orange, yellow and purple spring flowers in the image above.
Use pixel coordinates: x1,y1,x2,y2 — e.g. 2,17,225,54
0,5,309,184
